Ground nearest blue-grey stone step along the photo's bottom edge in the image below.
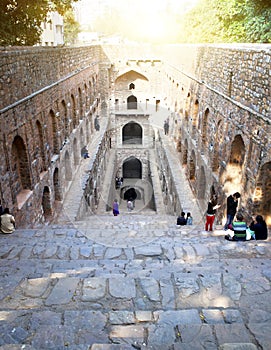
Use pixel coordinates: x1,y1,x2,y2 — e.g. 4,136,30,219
0,308,264,350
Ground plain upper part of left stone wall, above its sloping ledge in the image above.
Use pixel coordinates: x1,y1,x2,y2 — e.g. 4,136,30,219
0,46,100,109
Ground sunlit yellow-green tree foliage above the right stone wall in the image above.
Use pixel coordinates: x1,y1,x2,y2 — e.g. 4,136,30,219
179,0,271,43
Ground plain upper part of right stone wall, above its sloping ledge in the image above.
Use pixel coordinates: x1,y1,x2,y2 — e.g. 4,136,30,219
163,44,271,119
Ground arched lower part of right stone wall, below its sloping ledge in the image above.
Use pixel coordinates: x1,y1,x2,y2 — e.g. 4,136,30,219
164,74,271,225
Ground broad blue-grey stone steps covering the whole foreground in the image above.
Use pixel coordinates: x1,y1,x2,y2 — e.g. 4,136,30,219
0,213,271,350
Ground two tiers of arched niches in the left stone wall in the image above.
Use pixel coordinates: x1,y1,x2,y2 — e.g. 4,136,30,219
4,73,99,213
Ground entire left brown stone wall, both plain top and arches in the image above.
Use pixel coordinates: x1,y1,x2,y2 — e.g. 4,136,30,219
0,47,104,226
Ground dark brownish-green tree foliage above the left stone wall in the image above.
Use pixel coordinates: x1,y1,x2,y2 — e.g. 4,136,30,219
0,0,78,46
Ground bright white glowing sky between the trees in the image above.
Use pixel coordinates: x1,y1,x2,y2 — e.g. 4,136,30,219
76,0,198,42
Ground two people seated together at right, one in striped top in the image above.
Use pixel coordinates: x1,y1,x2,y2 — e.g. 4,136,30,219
225,212,268,241
